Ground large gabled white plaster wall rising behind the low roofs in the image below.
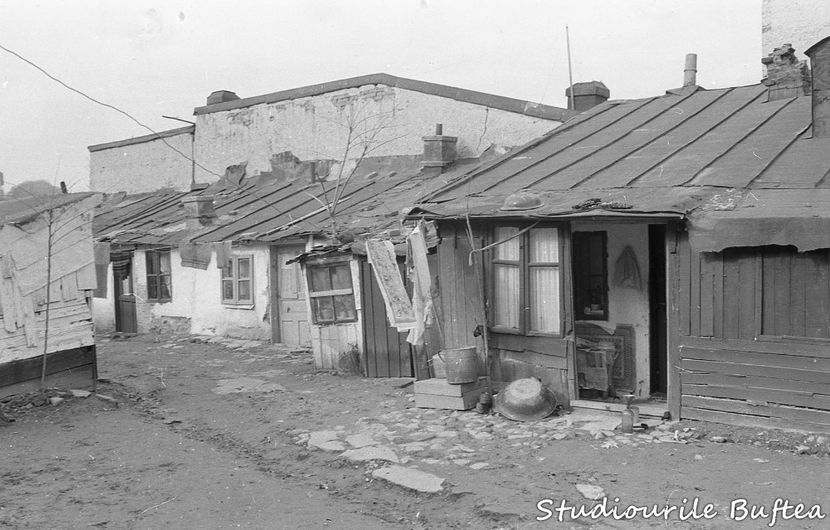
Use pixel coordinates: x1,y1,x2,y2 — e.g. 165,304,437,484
196,85,560,182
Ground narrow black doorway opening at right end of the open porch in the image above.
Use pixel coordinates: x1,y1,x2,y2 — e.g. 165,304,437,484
648,225,668,394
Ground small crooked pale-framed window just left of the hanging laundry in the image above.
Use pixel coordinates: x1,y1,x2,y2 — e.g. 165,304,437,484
307,261,357,324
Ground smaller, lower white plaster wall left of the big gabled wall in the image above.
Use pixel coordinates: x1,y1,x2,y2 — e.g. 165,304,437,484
89,134,192,193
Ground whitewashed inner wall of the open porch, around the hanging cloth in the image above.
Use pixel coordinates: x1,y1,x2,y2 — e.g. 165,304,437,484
572,222,651,397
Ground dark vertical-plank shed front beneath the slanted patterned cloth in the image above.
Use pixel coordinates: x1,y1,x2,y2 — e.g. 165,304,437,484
360,261,413,377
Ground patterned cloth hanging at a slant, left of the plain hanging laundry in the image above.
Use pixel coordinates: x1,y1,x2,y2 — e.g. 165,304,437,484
366,239,415,331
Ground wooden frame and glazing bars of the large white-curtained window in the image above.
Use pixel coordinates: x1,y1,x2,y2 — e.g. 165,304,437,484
486,222,567,338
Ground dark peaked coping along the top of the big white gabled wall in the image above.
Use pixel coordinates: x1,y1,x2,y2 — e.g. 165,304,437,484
193,73,576,122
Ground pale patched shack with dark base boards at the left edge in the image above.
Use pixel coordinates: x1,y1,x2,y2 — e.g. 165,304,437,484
0,193,98,397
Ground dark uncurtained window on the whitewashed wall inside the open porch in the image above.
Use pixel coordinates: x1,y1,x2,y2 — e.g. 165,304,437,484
573,232,608,320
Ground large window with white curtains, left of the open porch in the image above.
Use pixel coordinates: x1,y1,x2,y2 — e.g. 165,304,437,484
491,226,561,335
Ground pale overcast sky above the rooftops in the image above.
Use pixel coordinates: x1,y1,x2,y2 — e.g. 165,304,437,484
0,0,765,191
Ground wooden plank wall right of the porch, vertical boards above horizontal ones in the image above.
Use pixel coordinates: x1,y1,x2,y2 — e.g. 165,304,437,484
671,236,830,432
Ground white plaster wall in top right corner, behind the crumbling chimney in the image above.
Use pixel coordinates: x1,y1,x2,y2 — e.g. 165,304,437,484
761,0,830,59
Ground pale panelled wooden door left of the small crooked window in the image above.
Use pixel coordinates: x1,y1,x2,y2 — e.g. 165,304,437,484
276,245,311,346
